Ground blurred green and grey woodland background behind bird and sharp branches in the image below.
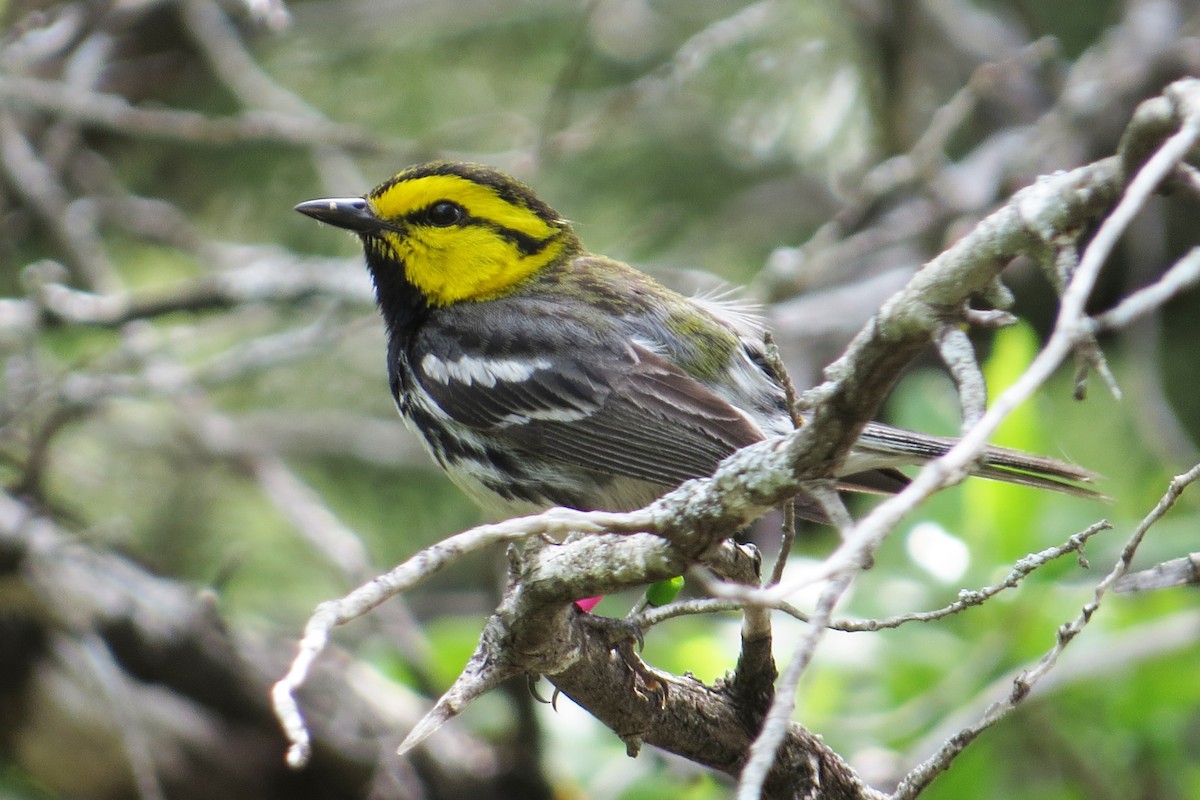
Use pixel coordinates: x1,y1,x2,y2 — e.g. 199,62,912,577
0,0,1200,800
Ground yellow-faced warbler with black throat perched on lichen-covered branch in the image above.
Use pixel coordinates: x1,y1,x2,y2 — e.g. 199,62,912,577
295,161,1094,521
